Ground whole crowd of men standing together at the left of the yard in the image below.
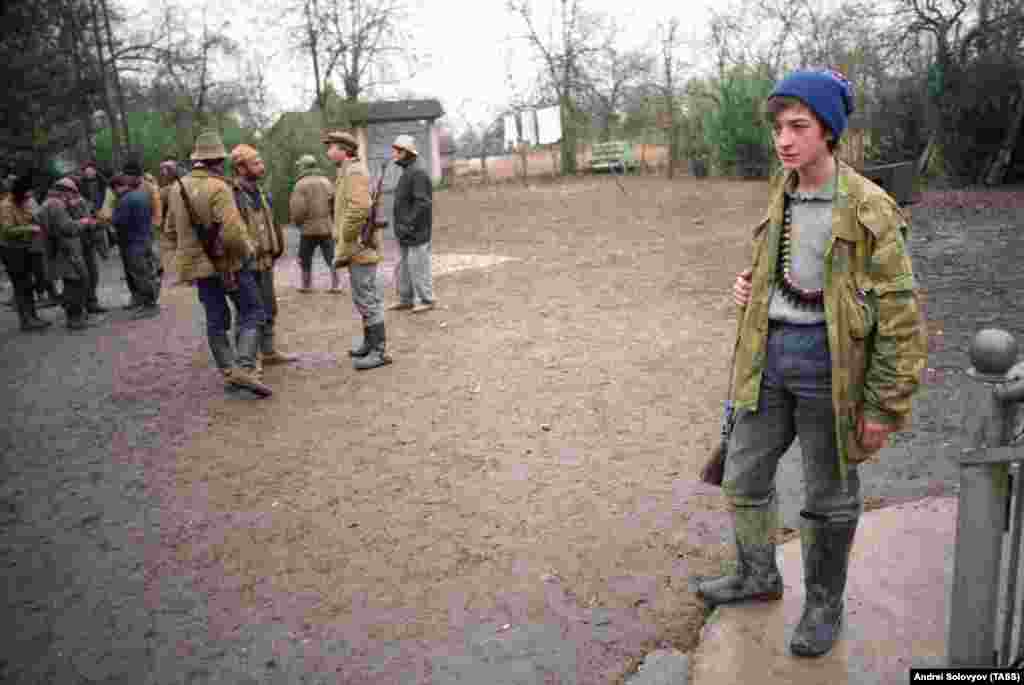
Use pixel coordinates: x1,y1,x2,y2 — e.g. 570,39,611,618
0,130,435,397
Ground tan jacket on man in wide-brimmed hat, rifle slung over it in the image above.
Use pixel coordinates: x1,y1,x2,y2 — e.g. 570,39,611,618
161,168,255,283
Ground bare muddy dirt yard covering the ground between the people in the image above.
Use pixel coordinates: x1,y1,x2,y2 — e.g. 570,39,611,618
0,177,1007,685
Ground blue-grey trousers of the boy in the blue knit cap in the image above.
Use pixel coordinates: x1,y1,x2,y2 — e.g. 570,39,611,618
722,322,861,522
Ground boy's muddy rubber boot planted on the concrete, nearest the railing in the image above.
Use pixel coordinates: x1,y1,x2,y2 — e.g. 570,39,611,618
790,513,857,656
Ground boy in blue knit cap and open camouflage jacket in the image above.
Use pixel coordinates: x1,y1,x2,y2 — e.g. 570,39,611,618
698,70,927,656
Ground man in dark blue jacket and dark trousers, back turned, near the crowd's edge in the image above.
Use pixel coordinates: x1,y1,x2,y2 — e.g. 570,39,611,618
111,174,160,318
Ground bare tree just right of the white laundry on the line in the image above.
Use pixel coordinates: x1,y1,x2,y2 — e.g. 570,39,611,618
507,0,613,174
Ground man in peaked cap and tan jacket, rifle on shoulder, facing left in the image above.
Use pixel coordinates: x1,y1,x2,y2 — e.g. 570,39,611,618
324,131,391,371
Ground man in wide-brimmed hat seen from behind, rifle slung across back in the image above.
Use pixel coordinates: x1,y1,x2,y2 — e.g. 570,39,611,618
163,131,271,397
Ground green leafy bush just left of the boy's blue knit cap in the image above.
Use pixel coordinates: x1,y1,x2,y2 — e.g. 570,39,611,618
703,67,774,175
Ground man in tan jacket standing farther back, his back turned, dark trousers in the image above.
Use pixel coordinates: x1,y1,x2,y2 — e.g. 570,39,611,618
289,155,341,294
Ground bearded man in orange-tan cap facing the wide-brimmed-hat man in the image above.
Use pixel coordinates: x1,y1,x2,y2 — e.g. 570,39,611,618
231,144,295,368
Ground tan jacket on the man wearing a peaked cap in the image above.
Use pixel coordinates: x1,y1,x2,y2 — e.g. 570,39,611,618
334,159,381,265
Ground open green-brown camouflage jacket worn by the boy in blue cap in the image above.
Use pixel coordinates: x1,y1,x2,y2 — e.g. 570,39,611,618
732,162,928,477
